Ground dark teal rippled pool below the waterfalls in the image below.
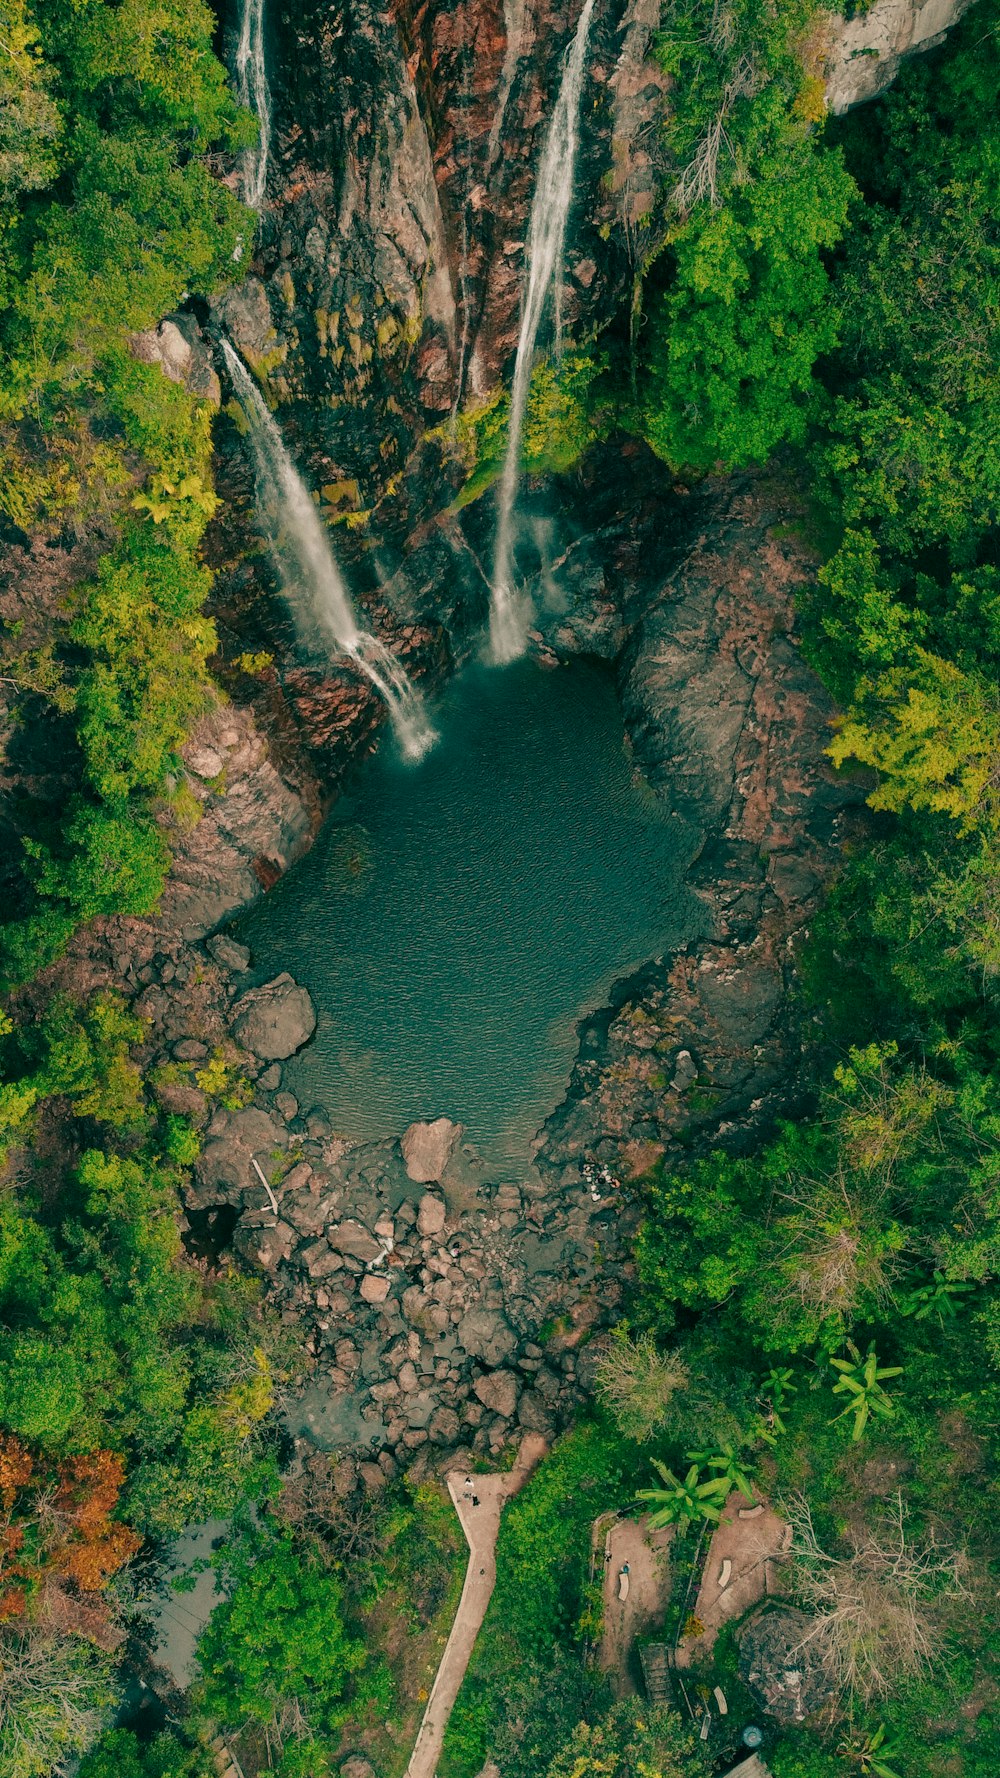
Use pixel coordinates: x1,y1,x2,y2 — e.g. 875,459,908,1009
238,661,699,1163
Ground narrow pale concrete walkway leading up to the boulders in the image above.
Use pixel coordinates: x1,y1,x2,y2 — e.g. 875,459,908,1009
406,1433,546,1778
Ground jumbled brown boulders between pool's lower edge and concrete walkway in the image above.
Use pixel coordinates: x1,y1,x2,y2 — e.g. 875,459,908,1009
201,1070,625,1486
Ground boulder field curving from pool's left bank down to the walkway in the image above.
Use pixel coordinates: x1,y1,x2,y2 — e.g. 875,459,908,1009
77,896,637,1486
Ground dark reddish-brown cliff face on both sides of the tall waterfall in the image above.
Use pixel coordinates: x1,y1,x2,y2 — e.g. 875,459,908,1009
222,0,664,546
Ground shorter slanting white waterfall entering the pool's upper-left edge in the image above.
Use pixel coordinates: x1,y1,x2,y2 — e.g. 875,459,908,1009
222,340,436,759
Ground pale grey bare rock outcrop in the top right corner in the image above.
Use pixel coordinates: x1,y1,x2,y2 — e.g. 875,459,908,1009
826,0,973,114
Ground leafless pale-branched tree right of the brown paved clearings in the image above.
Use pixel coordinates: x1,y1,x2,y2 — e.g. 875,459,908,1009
785,1495,966,1703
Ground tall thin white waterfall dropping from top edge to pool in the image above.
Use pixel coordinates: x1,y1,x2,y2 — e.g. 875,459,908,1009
489,0,594,661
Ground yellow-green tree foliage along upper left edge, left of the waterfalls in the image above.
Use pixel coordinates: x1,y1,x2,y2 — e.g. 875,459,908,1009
0,0,253,980
